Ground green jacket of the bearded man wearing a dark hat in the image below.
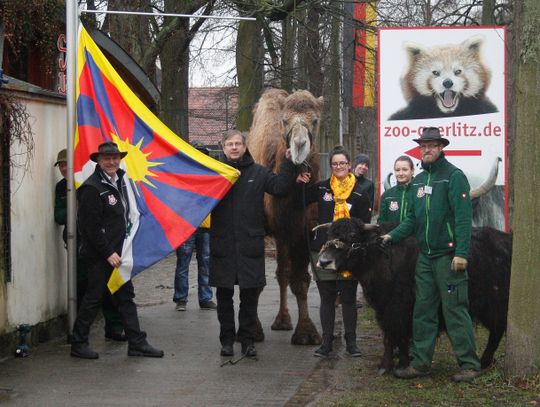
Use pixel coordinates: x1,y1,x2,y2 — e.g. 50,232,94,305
390,153,472,258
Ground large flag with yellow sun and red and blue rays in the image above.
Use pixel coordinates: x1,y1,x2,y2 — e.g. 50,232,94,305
74,28,238,292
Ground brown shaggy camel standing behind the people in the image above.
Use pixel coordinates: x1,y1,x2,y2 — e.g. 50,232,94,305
248,89,323,345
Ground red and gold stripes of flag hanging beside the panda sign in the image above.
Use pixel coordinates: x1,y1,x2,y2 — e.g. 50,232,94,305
352,0,377,107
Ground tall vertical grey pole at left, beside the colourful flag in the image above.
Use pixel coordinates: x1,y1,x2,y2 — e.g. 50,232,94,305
66,0,79,335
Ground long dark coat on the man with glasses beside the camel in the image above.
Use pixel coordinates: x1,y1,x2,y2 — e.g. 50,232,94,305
209,151,296,288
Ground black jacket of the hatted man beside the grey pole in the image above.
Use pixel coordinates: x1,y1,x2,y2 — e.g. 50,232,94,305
77,165,129,259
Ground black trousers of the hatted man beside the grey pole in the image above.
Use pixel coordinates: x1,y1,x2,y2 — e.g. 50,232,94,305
72,258,146,345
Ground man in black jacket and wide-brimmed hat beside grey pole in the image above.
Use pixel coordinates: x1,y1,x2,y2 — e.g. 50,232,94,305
71,141,163,359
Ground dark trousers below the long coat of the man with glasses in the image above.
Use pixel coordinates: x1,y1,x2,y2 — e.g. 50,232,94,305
216,287,260,345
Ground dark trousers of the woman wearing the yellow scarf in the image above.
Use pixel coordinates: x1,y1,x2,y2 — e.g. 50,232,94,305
317,280,358,336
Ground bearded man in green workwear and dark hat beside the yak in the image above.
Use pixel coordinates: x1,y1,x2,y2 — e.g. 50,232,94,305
380,127,480,382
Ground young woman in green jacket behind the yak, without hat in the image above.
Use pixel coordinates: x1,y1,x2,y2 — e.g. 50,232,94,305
377,155,414,224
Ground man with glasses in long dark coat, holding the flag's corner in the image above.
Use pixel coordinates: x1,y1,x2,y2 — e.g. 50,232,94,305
209,130,296,356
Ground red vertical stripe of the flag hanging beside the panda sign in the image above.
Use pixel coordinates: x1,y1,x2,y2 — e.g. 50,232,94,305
352,2,367,107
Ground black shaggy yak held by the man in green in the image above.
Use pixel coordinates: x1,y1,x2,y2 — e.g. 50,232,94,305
319,219,512,374
